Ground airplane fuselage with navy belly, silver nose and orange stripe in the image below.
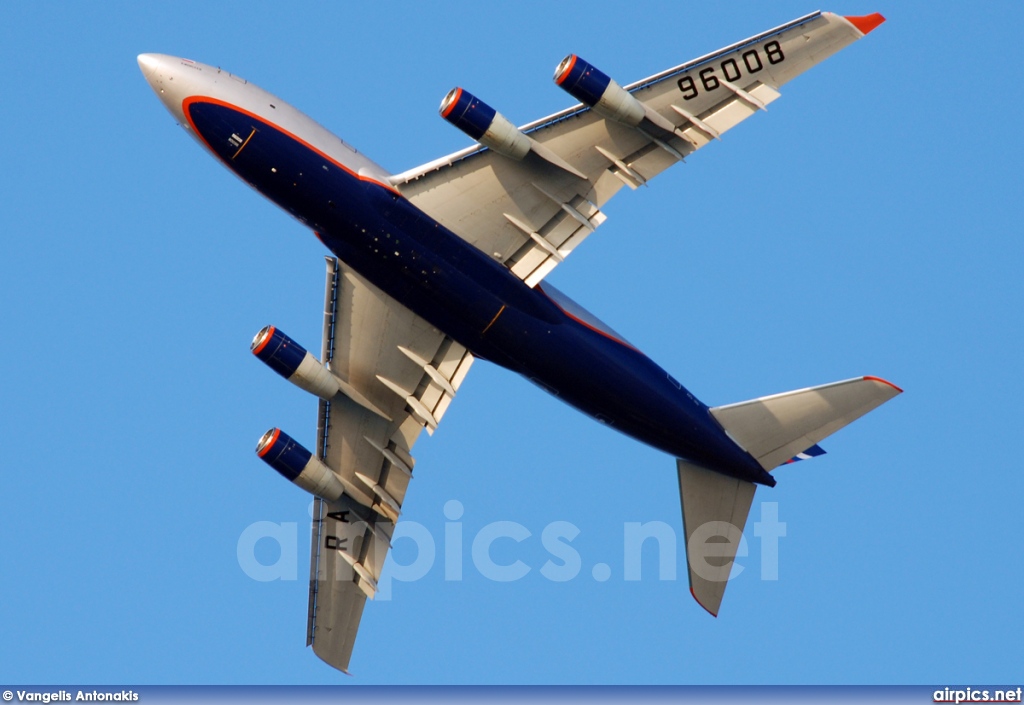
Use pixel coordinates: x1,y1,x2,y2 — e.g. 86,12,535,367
139,54,774,485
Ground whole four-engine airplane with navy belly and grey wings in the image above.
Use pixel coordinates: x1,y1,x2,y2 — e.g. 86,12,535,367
138,12,901,673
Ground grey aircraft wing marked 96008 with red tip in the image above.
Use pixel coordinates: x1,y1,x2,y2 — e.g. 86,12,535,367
391,12,883,286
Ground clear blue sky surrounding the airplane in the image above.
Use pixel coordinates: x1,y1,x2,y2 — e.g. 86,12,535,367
0,0,1024,685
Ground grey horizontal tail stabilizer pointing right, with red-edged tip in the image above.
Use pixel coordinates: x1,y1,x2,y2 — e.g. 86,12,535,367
711,377,902,470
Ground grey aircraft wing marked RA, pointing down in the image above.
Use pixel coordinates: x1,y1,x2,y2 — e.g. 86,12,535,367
306,257,473,672
